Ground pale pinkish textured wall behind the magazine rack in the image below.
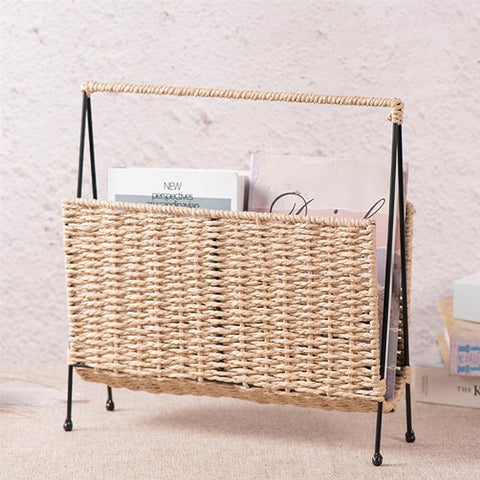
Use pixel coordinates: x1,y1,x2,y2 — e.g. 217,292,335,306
0,0,480,364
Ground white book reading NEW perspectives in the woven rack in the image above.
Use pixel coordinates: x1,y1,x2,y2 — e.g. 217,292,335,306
107,168,247,211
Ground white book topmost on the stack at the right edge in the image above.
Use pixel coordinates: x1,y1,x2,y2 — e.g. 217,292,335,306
453,272,480,323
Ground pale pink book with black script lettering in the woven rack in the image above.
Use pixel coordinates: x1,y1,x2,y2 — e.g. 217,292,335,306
248,153,407,398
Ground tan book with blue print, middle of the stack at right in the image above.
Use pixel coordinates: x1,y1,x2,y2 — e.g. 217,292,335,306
437,299,480,377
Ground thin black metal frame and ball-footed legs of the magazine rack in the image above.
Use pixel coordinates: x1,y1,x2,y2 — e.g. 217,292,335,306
63,92,415,466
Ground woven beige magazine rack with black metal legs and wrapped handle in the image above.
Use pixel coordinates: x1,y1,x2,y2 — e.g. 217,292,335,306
63,82,415,465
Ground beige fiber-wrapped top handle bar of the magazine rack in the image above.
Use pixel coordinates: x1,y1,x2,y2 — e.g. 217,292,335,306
82,82,403,125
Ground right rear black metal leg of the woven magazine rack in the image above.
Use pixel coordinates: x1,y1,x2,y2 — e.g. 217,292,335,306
397,125,415,443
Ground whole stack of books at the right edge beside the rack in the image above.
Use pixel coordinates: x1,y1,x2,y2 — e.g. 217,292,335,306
414,272,480,408
